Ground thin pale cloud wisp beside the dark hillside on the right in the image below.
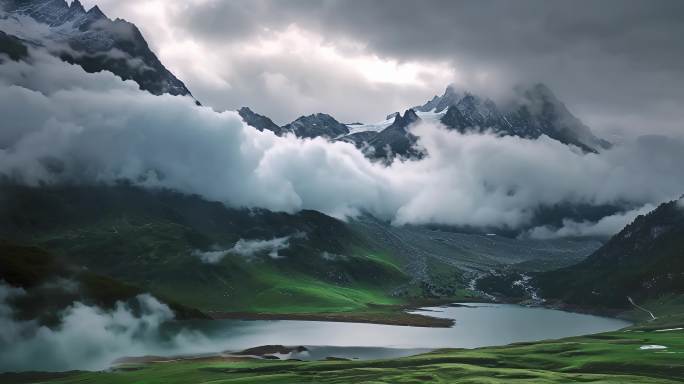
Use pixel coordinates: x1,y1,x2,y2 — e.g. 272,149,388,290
527,204,656,239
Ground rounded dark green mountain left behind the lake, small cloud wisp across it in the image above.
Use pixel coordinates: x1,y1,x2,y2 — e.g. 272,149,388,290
0,184,409,313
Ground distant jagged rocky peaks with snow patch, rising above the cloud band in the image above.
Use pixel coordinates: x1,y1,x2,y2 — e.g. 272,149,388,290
232,84,610,163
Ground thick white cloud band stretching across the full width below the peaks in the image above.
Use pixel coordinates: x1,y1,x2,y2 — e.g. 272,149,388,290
0,51,684,236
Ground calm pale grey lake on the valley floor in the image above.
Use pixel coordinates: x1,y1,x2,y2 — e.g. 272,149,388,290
164,304,629,359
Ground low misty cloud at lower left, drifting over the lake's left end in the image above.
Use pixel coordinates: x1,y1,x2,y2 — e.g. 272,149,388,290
0,282,216,372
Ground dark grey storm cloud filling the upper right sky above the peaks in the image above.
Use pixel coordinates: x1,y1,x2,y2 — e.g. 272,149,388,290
170,0,684,137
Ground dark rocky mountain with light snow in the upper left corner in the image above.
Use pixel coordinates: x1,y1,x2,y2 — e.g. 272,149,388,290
0,0,191,96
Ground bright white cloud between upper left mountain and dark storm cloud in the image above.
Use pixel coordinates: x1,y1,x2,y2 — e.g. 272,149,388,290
73,2,456,124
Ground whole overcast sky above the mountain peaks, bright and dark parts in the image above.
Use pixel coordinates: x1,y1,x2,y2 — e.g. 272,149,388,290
83,0,684,140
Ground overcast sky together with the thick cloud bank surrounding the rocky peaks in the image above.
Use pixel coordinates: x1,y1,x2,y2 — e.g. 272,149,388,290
0,0,684,237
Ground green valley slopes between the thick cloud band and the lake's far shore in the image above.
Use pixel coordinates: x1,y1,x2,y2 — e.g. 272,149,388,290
0,185,599,324
